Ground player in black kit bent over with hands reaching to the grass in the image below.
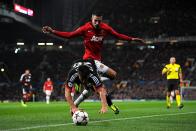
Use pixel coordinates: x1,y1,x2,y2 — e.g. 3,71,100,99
65,60,119,114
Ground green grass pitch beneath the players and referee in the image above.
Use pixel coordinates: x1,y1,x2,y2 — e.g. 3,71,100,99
0,101,196,131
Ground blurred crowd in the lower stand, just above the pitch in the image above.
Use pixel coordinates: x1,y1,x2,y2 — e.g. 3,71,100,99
0,43,196,100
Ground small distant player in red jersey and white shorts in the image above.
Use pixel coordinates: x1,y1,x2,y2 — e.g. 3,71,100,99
43,78,53,104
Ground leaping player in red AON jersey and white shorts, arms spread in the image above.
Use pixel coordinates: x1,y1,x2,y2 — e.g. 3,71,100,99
42,13,143,79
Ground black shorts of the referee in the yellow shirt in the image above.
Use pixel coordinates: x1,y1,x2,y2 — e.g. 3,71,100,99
167,79,180,92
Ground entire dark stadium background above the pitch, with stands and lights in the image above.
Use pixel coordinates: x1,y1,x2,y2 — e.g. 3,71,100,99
0,0,196,102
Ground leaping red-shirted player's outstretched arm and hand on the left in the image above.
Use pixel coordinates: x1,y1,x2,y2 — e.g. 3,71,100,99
42,26,84,38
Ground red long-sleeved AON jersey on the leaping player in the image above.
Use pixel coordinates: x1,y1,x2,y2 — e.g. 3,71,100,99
54,22,133,61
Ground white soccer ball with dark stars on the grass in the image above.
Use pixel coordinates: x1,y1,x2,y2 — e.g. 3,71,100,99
72,111,89,126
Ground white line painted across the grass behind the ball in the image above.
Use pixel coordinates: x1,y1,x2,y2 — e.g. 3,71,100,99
0,112,196,131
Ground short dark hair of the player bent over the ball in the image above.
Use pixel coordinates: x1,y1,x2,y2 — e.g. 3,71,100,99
78,65,90,80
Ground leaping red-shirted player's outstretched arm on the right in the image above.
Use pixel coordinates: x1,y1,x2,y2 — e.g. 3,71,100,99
106,25,145,43
